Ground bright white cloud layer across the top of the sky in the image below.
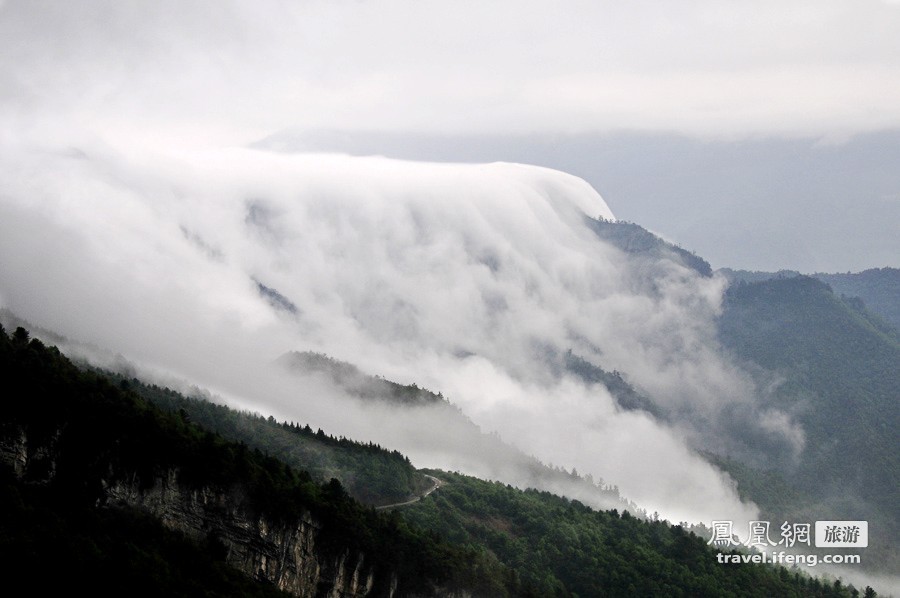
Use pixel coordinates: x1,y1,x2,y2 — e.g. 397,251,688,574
0,0,900,143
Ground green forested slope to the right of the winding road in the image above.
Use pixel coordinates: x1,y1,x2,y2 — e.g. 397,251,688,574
403,471,853,597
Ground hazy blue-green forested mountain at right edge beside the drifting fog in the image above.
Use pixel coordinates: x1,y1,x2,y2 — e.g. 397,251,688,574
719,276,900,567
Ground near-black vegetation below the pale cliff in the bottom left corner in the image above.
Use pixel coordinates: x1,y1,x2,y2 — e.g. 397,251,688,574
0,474,285,598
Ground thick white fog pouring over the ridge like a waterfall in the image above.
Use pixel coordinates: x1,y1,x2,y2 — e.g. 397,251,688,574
0,135,802,521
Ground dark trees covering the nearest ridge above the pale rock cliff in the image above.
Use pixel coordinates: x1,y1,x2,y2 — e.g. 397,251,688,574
0,328,523,596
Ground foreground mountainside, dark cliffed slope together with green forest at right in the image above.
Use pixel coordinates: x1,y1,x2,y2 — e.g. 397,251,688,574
0,328,872,597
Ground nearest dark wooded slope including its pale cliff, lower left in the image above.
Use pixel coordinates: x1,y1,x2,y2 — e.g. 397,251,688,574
0,328,512,596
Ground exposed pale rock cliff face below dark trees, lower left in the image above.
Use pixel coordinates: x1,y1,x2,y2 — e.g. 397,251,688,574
0,425,397,598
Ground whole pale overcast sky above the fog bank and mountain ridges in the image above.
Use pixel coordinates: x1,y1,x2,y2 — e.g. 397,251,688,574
0,0,900,271
